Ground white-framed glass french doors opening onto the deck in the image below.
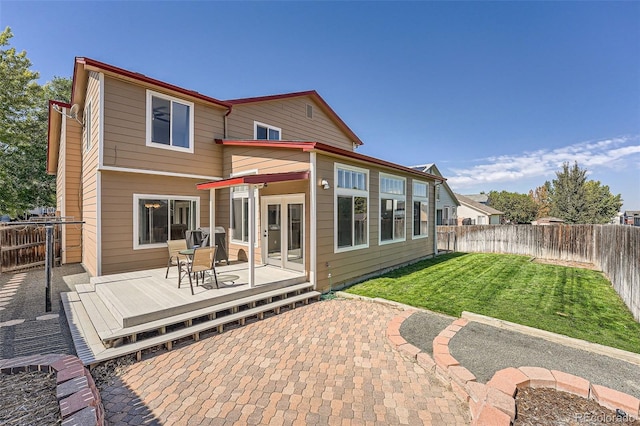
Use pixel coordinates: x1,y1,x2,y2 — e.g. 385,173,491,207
260,194,305,271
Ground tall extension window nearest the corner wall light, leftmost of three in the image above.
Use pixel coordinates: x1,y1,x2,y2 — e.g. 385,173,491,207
334,164,369,252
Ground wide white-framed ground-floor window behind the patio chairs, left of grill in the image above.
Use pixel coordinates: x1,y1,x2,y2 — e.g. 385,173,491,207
133,194,200,249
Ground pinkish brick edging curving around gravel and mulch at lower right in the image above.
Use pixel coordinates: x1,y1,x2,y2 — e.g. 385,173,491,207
387,310,640,426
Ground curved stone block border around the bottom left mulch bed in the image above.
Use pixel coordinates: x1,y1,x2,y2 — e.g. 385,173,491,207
0,354,105,426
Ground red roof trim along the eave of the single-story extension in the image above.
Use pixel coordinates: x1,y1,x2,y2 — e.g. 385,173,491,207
216,139,446,182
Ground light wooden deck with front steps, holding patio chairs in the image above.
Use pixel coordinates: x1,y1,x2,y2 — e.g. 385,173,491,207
62,264,320,365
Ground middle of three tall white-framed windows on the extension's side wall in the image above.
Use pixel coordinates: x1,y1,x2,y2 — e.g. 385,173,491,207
380,173,406,243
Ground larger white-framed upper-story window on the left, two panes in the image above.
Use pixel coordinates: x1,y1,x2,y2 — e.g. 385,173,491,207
147,90,193,153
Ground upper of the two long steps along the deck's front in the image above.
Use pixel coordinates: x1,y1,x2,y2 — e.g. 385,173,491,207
98,282,313,346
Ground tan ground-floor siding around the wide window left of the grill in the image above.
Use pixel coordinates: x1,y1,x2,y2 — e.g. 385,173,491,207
101,172,209,275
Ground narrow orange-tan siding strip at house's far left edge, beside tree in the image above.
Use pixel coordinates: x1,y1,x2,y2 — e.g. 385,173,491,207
56,117,82,263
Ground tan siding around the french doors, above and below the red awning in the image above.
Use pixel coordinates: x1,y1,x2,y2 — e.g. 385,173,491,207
216,146,310,265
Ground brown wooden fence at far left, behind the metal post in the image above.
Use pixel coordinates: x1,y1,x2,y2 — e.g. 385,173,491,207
0,224,60,273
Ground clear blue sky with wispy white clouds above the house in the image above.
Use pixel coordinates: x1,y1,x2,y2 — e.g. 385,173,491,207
0,0,640,210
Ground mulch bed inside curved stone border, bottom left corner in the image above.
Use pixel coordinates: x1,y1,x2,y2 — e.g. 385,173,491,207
0,371,62,426
